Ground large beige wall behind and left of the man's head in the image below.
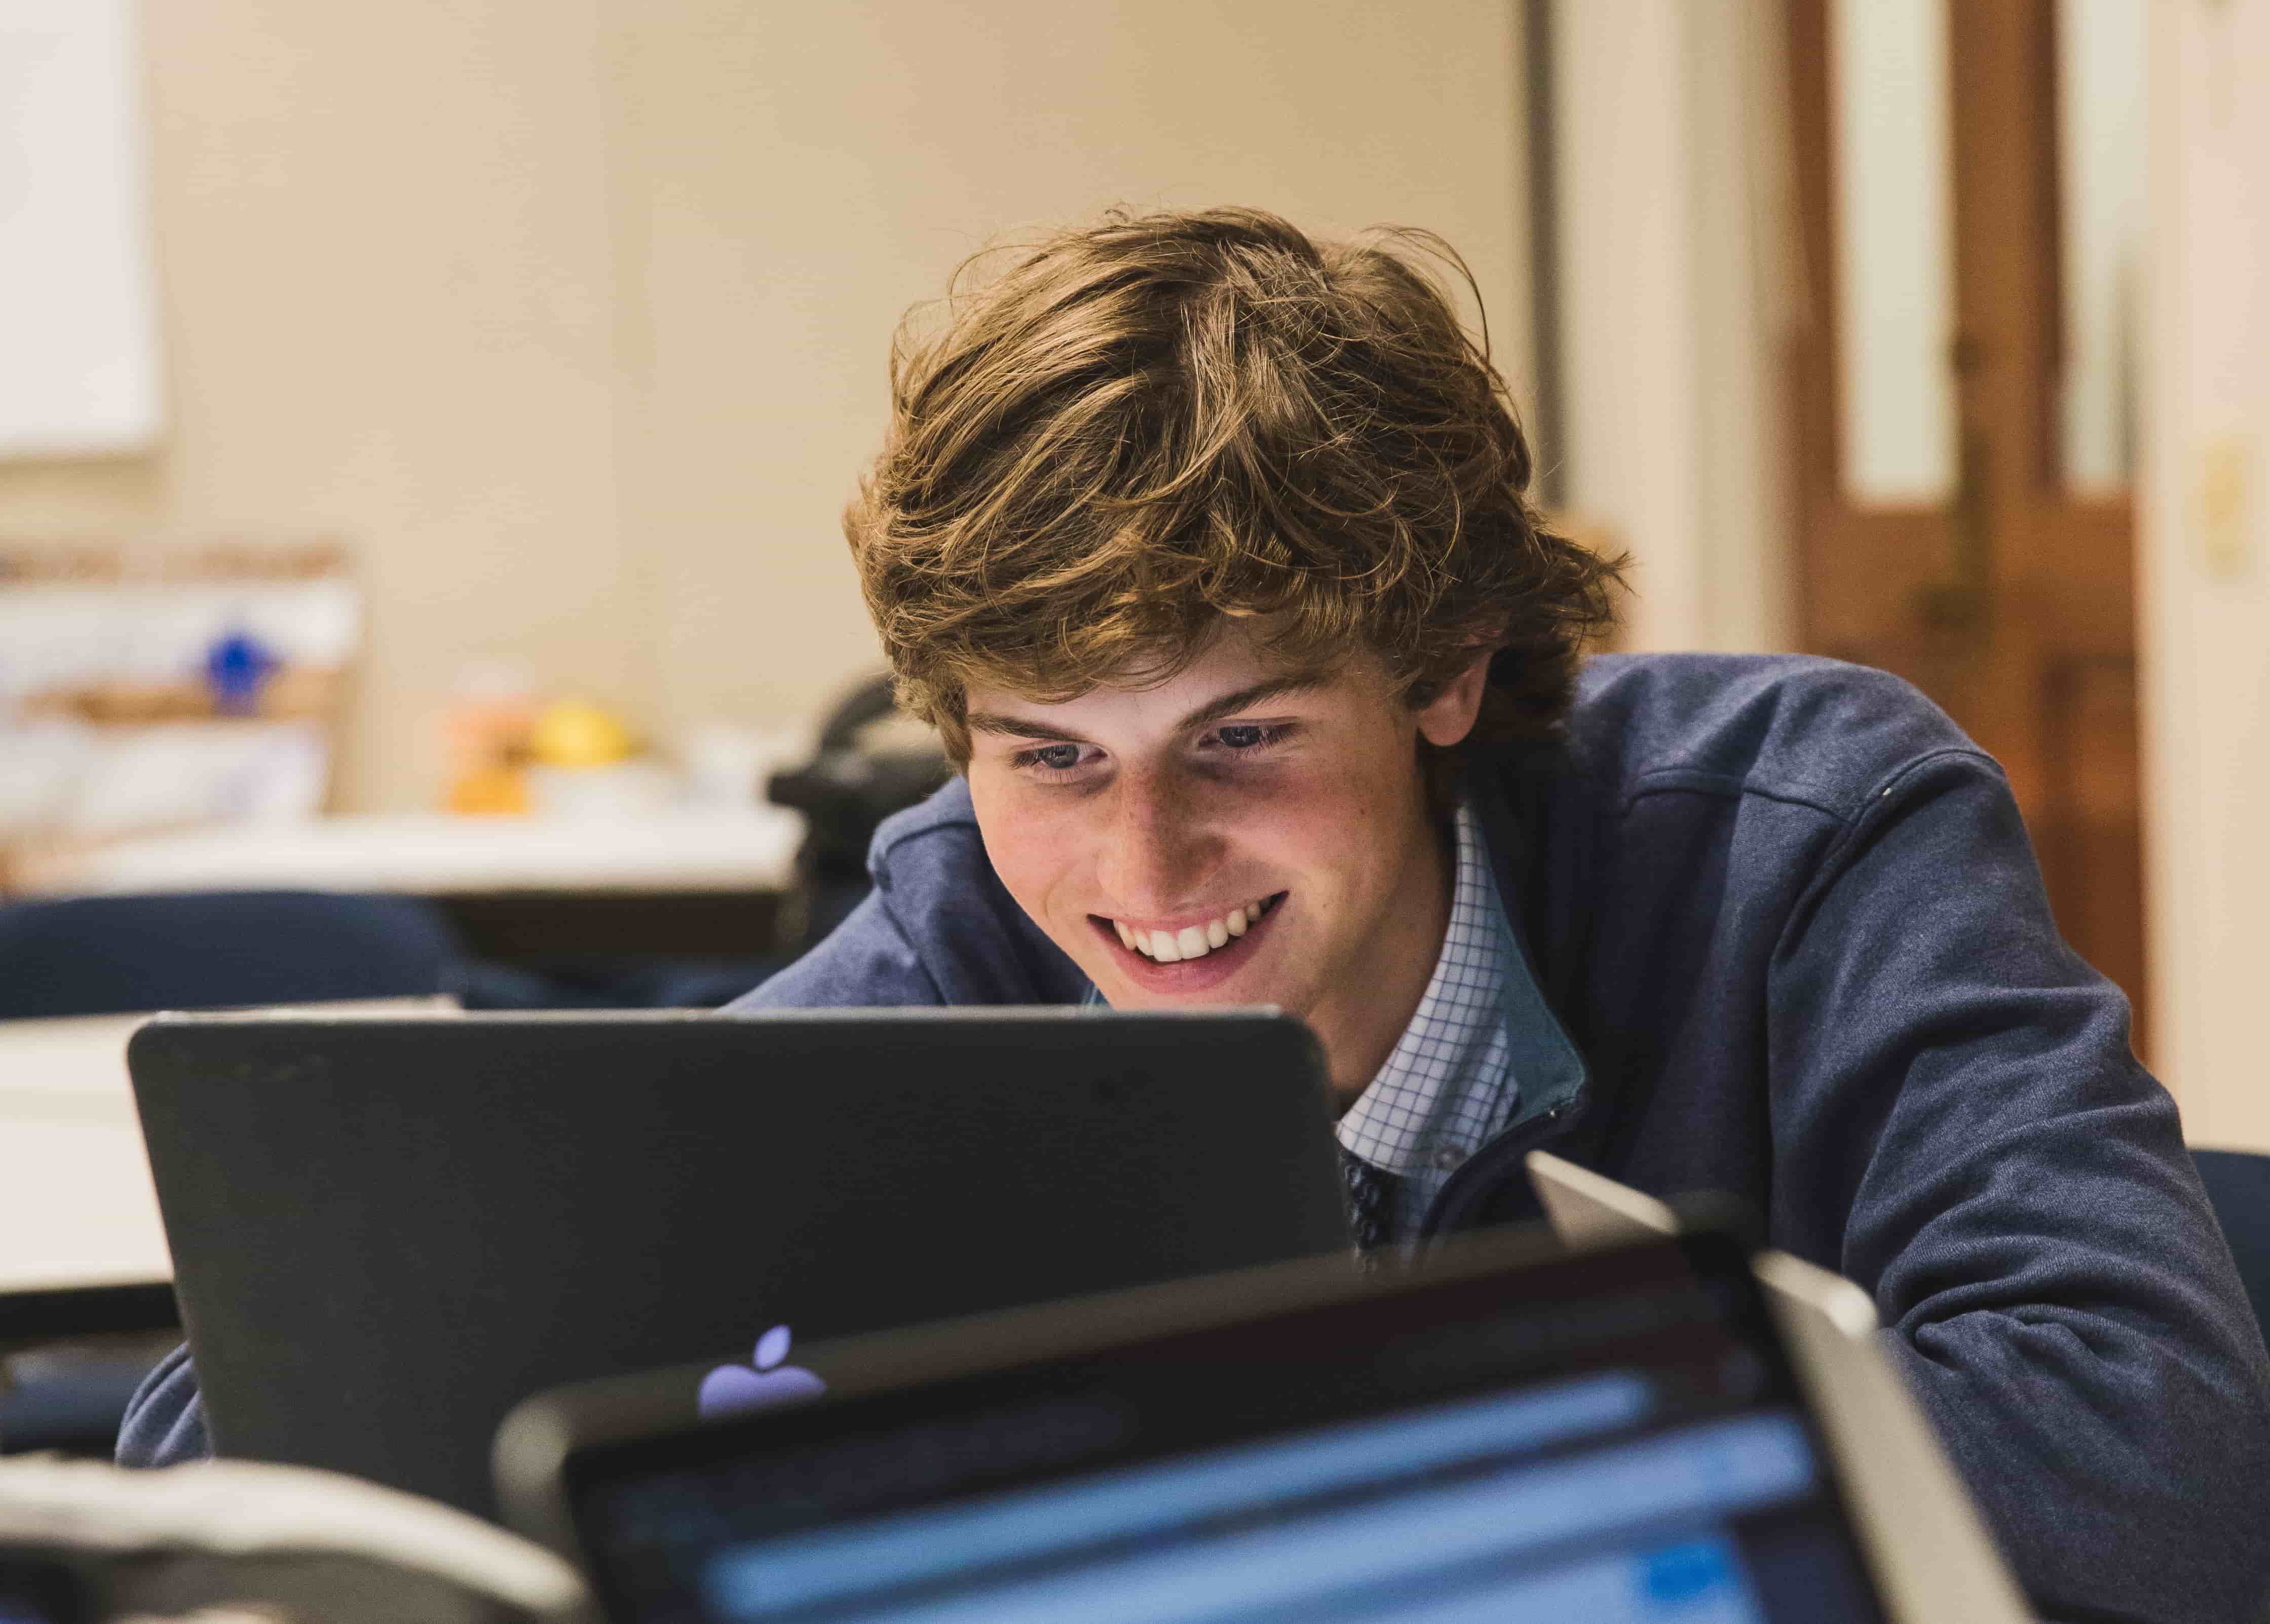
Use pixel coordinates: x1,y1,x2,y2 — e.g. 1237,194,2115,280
0,0,1530,806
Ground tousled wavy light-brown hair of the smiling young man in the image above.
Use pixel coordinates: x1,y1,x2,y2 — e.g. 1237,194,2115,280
845,209,1623,785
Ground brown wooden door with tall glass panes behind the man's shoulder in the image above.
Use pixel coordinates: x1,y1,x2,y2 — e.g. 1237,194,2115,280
1789,0,2145,1051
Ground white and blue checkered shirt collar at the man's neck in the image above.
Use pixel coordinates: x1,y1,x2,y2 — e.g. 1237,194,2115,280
1339,802,1517,1177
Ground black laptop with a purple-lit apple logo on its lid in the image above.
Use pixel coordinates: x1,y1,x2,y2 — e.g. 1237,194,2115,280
127,1008,1348,1513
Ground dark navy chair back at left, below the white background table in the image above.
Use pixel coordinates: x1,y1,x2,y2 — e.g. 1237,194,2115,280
0,890,463,1020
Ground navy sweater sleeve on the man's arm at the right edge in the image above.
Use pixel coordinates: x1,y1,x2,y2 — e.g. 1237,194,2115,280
1770,749,2270,1624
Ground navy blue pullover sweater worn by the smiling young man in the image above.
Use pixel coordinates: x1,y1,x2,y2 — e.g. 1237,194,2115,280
120,654,2270,1624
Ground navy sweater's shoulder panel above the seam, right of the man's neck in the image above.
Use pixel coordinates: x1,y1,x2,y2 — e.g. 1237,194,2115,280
1569,654,1997,820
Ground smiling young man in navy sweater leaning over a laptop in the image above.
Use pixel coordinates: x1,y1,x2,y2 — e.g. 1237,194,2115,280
120,209,2270,1622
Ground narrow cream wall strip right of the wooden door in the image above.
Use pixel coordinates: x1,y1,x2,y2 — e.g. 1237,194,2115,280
2138,0,2270,1149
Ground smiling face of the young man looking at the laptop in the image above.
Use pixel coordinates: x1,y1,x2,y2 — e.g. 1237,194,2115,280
967,622,1485,1097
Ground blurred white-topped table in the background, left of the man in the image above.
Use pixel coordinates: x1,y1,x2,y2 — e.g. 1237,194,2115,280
18,804,804,963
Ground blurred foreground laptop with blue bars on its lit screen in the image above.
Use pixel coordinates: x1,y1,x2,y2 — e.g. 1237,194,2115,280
497,1231,1884,1624
